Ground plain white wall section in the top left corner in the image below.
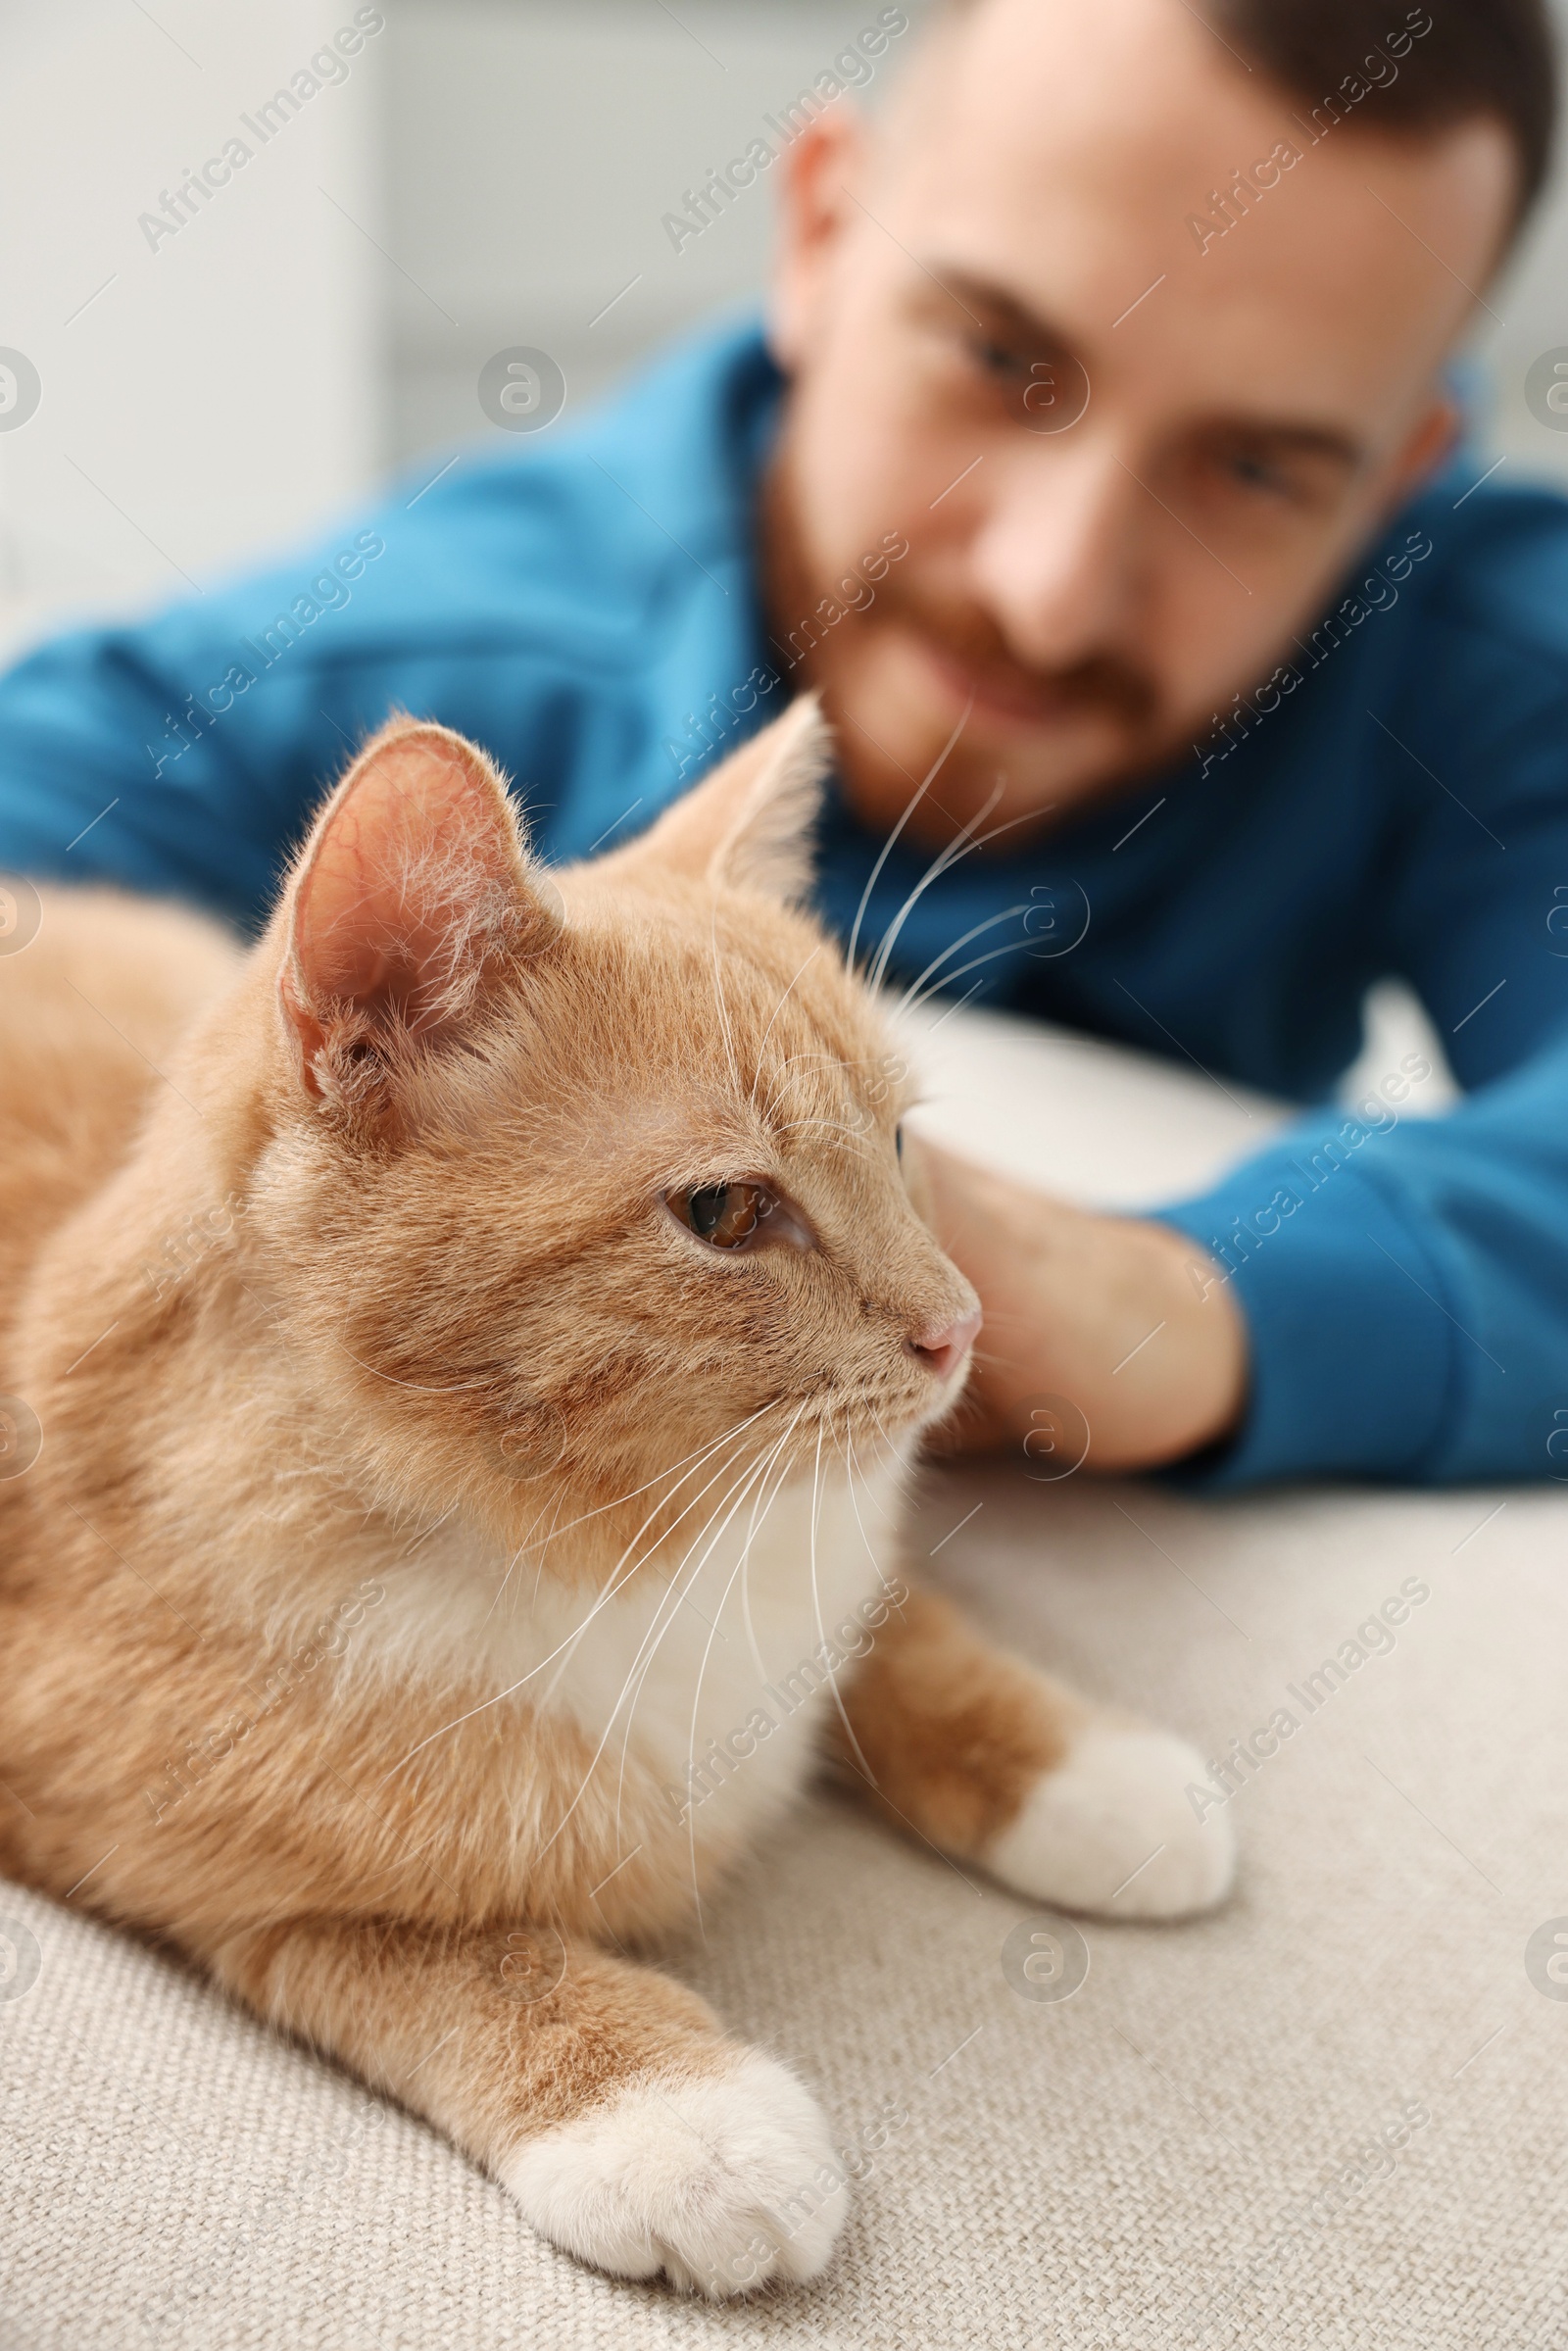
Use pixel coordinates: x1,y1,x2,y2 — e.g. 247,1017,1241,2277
0,0,388,637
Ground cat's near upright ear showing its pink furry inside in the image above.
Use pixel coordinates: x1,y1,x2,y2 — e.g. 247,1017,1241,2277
277,719,560,1096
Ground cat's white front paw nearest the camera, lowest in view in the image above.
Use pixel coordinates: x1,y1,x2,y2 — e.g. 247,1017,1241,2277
501,2050,849,2302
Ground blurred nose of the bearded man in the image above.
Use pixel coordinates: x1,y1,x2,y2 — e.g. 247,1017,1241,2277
971,434,1148,670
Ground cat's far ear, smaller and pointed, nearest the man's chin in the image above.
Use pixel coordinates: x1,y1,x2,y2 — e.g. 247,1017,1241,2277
607,694,832,906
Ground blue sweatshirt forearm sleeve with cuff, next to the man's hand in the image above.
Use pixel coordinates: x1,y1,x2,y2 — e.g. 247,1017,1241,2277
1159,1035,1568,1491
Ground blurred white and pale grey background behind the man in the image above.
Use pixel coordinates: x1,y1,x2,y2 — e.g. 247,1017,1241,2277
0,0,1568,647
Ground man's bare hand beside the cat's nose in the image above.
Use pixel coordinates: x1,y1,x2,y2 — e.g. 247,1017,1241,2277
909,1141,1246,1469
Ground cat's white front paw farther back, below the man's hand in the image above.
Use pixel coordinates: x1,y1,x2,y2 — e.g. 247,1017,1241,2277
985,1723,1237,1919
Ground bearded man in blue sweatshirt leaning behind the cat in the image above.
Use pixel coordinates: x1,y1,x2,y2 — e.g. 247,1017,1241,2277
0,0,1568,1486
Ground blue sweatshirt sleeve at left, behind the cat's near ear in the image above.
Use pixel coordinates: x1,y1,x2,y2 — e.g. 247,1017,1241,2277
0,318,780,921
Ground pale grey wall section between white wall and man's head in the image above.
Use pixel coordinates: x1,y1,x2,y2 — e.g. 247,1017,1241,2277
375,0,921,463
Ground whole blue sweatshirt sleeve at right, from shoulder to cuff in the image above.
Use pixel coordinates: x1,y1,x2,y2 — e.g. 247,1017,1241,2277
1161,496,1568,1491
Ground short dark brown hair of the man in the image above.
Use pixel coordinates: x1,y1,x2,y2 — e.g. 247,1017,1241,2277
1203,0,1556,223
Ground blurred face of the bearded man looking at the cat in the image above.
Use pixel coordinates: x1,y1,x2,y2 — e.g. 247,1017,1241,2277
766,0,1514,842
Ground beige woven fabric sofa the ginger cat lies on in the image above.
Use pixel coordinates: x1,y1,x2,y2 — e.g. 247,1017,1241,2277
0,1015,1568,2351
